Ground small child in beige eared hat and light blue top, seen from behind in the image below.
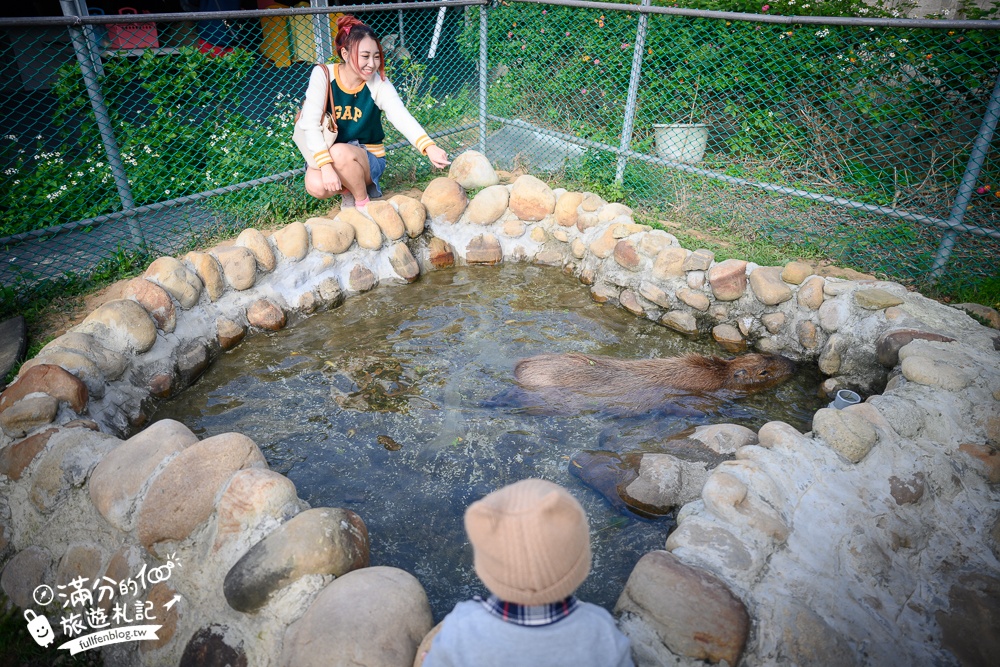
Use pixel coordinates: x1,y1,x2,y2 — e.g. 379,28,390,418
418,479,633,667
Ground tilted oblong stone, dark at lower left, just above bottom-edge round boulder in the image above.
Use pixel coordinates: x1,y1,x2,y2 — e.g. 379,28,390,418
223,507,369,613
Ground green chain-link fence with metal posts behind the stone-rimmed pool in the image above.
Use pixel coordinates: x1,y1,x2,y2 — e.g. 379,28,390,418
0,0,1000,316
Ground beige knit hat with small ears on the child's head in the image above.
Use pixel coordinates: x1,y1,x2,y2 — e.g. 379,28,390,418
465,479,590,605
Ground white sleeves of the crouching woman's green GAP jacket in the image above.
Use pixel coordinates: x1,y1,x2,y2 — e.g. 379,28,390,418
298,65,435,167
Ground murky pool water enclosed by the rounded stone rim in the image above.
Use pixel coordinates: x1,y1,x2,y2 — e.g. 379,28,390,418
154,265,826,619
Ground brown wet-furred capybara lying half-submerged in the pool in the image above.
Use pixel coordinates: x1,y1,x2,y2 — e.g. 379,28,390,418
514,352,795,415
